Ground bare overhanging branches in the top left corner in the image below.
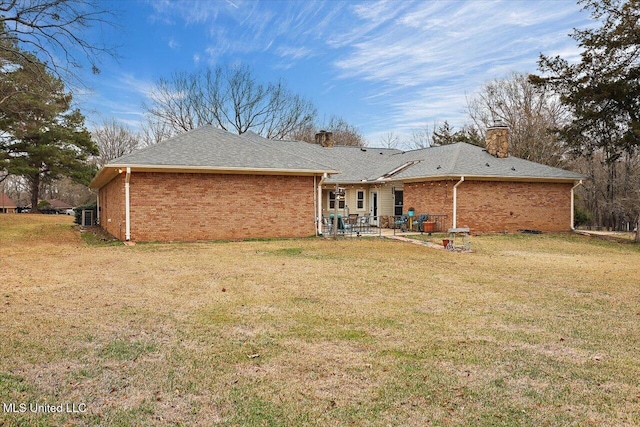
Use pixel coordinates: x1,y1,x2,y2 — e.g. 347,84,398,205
0,0,116,86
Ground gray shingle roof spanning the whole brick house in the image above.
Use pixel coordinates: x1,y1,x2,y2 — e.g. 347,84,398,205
94,126,586,189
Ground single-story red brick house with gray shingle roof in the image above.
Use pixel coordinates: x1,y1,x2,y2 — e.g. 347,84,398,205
91,126,584,241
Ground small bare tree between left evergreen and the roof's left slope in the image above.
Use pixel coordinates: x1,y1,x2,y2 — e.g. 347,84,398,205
92,119,139,167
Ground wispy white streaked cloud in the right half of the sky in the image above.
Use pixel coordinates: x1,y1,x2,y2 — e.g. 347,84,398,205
328,1,586,140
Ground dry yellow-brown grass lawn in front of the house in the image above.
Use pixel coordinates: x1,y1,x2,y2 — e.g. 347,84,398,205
0,215,640,426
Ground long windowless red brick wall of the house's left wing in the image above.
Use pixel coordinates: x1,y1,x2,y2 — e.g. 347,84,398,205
123,172,315,241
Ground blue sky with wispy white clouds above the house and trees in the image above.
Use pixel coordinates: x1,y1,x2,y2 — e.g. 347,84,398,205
76,0,592,145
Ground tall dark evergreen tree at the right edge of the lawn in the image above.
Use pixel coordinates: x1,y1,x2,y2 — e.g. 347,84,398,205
530,0,640,241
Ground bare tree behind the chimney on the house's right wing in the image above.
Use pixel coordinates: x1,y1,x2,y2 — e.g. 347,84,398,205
467,73,568,166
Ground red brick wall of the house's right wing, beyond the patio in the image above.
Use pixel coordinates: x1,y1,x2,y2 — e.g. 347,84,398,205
404,180,572,232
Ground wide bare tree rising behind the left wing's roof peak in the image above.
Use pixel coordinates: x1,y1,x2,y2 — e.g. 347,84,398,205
144,66,316,139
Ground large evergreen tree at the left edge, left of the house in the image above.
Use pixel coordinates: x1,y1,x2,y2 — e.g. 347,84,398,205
0,49,98,211
